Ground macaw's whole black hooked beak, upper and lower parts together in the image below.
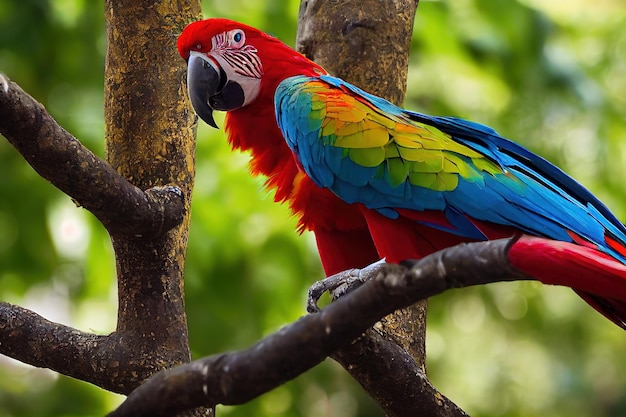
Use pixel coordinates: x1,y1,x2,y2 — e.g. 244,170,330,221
187,52,245,128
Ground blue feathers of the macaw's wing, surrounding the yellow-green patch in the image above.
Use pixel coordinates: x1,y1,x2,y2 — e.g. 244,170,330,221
275,75,626,261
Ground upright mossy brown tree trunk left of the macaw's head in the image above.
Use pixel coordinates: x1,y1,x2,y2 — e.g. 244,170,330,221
104,0,200,391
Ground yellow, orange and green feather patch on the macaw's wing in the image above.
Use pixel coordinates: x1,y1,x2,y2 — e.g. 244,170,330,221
314,81,502,191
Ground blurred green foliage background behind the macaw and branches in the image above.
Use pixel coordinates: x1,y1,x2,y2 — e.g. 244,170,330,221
0,0,626,417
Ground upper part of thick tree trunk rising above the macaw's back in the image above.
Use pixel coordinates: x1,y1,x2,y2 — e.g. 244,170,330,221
296,0,419,105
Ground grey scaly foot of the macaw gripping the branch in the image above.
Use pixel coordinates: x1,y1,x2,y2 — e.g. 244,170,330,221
306,259,385,313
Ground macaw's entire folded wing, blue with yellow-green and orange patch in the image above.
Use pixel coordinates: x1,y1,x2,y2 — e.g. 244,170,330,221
275,76,626,259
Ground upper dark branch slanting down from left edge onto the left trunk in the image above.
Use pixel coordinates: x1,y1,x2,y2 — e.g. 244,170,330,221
0,74,185,238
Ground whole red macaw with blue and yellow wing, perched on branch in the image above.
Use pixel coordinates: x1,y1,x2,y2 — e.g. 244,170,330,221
178,18,626,329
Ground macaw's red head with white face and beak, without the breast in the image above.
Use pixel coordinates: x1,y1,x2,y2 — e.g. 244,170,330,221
178,19,325,127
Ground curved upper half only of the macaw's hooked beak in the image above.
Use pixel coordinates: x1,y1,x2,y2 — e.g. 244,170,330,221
187,51,221,128
